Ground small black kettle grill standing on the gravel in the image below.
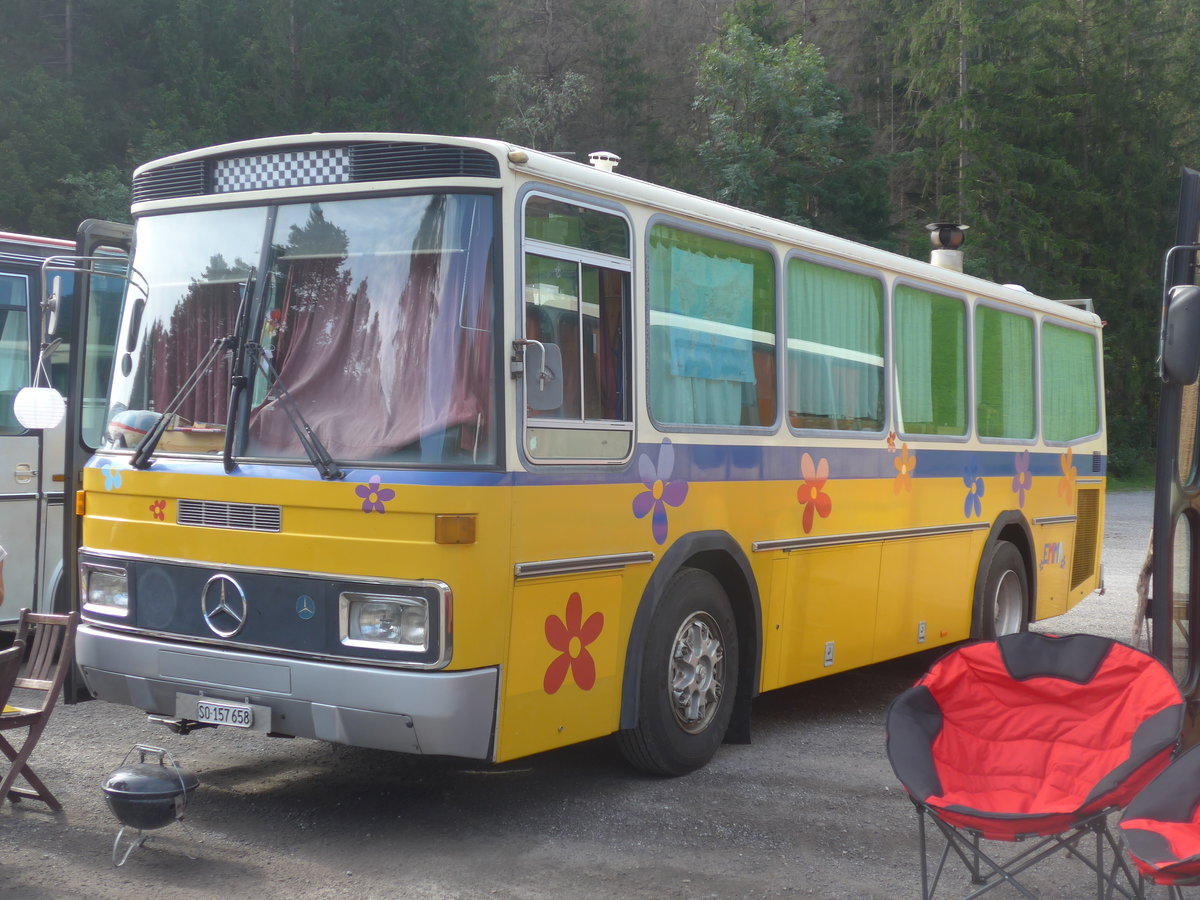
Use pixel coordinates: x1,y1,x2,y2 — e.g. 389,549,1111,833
104,744,200,866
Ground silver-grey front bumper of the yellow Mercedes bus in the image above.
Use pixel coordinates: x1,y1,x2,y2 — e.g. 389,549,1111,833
76,623,499,760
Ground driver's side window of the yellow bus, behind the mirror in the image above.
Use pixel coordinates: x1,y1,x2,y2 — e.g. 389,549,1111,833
522,196,632,462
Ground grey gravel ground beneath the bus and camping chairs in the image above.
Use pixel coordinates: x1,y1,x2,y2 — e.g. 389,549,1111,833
0,493,1171,900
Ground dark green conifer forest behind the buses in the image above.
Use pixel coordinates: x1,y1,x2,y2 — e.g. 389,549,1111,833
0,0,1200,476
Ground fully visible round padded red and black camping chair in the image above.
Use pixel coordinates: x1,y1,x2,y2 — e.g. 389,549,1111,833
887,632,1183,900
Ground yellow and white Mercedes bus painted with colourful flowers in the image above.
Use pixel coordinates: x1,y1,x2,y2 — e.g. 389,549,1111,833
77,134,1106,774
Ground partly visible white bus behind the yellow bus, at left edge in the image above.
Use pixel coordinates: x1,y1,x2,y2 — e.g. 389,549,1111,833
0,229,125,629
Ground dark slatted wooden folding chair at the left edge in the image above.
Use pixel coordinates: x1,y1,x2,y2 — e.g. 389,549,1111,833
0,610,79,812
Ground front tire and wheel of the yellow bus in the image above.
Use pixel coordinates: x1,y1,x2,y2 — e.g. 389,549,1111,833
618,569,738,775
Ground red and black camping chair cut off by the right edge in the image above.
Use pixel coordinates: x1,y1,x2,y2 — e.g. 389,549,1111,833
1118,746,1200,898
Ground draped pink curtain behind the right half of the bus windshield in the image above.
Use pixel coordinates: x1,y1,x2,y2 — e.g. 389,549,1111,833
247,198,492,460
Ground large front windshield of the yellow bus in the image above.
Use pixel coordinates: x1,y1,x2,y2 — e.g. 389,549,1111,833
108,193,497,466
